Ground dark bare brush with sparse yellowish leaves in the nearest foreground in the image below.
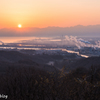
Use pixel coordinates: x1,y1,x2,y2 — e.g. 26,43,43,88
0,66,100,100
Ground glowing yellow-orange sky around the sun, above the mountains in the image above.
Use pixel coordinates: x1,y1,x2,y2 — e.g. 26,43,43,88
0,0,100,28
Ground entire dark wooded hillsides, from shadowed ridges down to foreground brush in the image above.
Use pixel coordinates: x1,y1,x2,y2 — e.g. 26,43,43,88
0,51,100,100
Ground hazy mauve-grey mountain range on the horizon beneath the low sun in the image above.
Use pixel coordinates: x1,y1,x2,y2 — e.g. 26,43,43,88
0,25,100,37
